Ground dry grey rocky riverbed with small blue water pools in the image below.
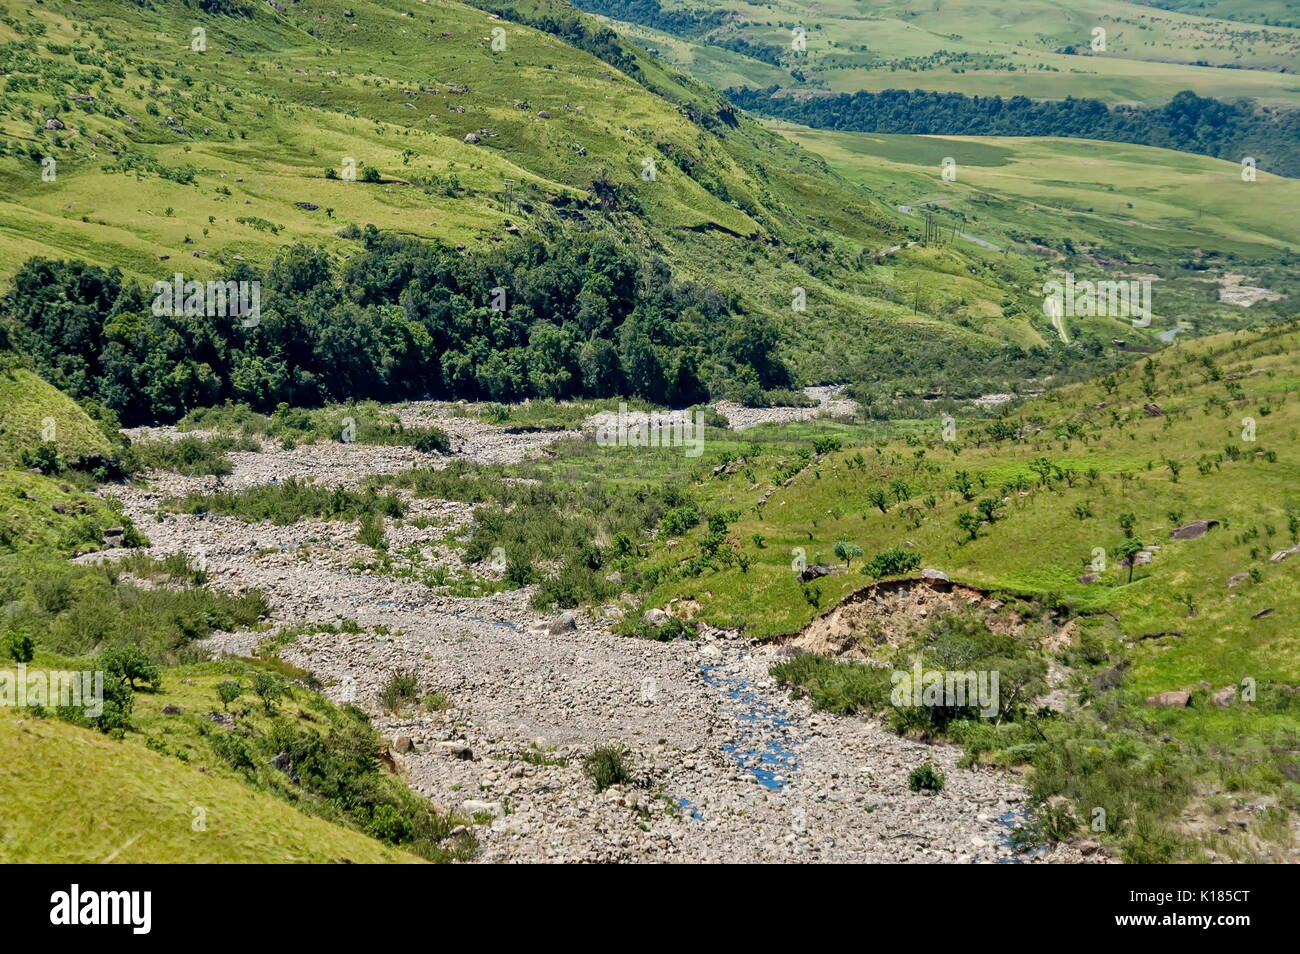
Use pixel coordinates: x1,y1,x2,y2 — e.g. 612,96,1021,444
91,395,1092,862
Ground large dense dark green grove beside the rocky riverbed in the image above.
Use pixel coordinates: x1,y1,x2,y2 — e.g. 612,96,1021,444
0,226,792,423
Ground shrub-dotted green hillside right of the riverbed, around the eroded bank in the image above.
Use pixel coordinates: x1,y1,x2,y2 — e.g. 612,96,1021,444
473,322,1300,860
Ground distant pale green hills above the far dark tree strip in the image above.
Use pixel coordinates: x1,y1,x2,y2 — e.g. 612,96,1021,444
579,0,1300,107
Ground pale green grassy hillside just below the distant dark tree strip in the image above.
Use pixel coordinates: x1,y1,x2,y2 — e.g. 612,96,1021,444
770,121,1300,334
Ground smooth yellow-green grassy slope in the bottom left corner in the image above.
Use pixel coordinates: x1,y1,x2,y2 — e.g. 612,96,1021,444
0,710,421,864
